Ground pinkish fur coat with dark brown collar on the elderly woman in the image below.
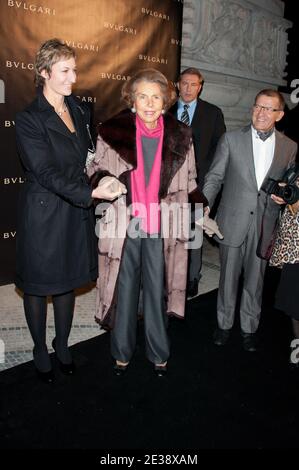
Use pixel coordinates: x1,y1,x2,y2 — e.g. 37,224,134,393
88,111,207,328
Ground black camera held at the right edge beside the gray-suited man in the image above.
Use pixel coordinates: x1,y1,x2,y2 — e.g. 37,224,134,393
261,165,299,204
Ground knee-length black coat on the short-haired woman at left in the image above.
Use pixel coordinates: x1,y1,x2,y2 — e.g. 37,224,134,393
16,93,97,295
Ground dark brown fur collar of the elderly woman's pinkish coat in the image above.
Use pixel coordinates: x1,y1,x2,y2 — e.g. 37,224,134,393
98,110,192,198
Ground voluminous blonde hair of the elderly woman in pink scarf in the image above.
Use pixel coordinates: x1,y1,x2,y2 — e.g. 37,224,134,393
121,69,177,110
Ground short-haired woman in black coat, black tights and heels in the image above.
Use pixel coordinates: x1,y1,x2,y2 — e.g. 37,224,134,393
16,39,122,382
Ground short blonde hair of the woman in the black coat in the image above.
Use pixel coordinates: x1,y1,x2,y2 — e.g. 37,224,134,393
34,38,76,87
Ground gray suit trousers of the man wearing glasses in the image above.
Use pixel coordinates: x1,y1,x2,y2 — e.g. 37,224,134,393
217,221,267,333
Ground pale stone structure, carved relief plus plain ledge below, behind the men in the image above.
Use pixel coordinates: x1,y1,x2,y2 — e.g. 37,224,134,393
181,0,292,129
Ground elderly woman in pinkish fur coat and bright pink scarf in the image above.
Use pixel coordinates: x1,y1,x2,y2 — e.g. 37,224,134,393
89,69,211,376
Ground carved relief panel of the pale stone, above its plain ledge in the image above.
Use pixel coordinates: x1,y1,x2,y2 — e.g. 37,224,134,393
184,0,290,78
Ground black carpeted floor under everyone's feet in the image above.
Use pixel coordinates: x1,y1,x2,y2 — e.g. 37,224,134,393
0,268,299,450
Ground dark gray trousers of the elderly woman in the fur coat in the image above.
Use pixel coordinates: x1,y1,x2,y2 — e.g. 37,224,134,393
111,237,169,364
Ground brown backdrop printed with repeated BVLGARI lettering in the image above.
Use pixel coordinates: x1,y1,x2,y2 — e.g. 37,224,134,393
0,0,183,284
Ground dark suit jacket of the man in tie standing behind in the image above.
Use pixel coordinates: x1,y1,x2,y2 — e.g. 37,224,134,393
170,98,226,189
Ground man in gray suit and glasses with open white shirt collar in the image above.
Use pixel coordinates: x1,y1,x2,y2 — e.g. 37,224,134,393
203,89,297,351
